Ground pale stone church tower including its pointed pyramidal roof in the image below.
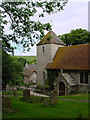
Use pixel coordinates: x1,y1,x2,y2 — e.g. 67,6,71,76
37,31,66,86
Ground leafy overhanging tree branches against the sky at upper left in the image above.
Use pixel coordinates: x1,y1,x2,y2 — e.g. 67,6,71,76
0,0,68,52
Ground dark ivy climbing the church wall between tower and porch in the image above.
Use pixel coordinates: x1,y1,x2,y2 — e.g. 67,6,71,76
47,70,58,91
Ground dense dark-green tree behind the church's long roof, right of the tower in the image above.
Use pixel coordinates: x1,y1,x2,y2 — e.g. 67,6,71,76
59,28,90,46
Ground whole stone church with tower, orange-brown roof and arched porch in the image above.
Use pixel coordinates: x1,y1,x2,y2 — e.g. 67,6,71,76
37,31,90,95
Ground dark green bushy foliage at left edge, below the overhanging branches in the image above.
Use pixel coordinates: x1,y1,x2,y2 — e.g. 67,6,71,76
2,51,23,88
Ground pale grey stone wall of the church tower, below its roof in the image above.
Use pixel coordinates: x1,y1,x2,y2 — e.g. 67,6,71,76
37,44,63,86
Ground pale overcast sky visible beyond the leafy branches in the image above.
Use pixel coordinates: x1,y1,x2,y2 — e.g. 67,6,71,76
11,0,89,56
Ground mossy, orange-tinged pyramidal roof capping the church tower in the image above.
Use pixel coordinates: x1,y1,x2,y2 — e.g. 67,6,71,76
37,31,66,45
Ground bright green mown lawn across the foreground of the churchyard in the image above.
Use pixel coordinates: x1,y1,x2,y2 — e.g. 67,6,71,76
3,97,88,118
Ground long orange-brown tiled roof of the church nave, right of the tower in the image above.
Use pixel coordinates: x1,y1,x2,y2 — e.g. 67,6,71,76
46,44,90,70
